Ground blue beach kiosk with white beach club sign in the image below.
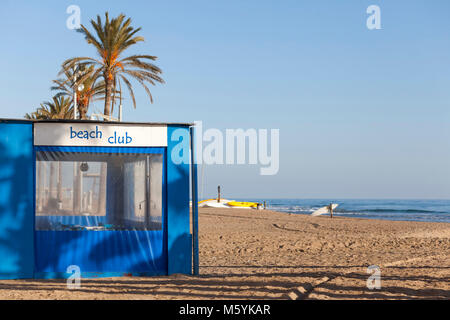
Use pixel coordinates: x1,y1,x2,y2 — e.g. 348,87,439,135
0,119,198,279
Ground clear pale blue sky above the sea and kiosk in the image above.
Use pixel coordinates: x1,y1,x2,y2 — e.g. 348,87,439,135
0,0,450,199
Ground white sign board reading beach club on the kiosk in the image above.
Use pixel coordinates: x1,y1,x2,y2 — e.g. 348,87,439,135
34,123,167,147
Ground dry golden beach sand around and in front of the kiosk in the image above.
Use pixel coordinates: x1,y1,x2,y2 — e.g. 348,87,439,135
0,208,450,299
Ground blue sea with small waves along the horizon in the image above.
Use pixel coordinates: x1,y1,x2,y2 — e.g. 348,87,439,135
236,199,450,223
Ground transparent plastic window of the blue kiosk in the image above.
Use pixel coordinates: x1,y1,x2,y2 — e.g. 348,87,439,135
36,151,163,230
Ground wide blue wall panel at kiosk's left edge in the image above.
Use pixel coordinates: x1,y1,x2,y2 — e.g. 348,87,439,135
0,123,34,279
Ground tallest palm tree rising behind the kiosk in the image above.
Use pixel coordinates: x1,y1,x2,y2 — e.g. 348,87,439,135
61,12,164,116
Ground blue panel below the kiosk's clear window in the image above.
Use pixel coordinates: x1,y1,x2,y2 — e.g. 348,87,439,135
36,230,167,275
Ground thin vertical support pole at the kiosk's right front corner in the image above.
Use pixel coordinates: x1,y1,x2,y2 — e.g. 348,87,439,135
189,127,199,275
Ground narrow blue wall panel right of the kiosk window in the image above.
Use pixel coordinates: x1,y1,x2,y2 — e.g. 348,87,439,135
167,126,192,274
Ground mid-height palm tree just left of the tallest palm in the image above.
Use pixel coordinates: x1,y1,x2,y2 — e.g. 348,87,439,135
51,64,113,119
